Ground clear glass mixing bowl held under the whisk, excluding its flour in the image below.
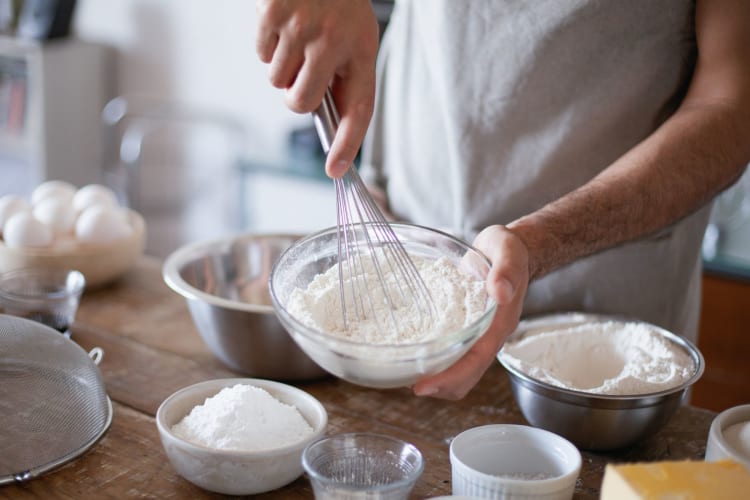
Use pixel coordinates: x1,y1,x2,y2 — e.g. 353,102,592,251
270,224,497,388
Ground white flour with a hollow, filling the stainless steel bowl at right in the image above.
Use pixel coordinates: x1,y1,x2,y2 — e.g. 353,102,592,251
501,321,695,396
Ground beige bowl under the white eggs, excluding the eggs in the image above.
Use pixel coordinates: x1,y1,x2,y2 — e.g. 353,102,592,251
0,210,145,289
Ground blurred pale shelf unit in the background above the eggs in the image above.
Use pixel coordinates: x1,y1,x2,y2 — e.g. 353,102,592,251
0,36,110,195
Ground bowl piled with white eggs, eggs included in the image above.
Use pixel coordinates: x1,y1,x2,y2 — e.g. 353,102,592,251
0,180,145,287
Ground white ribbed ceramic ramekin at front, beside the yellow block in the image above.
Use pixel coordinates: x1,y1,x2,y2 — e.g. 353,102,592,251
450,424,581,500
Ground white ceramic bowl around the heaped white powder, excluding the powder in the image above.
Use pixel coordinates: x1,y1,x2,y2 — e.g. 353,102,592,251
156,378,328,495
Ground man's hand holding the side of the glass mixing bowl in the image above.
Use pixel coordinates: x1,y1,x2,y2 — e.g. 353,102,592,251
414,226,529,400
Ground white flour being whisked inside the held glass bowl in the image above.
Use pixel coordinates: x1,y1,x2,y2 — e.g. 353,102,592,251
287,255,487,344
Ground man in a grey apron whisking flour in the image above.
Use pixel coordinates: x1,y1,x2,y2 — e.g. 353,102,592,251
257,0,750,399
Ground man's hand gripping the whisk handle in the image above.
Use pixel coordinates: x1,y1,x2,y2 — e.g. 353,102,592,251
256,0,378,177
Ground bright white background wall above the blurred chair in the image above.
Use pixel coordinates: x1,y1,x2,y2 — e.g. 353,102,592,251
73,0,307,160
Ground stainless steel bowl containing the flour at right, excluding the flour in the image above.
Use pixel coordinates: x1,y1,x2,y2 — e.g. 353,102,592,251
497,313,704,450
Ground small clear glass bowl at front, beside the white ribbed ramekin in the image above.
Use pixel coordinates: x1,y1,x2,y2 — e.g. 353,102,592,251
302,433,424,500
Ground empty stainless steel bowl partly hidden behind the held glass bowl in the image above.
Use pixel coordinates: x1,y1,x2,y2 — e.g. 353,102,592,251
163,234,326,380
